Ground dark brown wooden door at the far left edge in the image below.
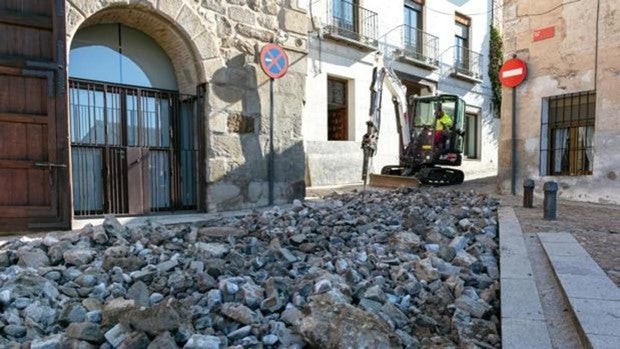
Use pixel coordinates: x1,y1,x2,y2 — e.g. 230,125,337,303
0,0,71,234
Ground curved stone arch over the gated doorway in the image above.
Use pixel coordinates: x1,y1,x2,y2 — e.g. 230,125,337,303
67,0,217,94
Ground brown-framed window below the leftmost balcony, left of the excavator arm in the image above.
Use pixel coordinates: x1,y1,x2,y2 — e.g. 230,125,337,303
327,78,349,141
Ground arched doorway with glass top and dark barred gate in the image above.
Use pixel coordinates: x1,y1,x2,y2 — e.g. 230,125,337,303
68,23,201,216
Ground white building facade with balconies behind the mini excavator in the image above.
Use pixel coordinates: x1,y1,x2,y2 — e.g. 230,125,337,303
299,0,499,186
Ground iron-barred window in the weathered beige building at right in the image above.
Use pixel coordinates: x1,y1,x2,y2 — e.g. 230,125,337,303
541,91,596,176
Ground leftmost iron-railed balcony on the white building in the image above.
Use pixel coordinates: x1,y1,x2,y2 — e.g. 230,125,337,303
325,0,378,50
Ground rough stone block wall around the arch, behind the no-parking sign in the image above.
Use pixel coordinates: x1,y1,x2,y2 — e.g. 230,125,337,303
66,0,308,211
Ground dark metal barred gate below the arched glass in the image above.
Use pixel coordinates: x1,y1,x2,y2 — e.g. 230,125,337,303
69,79,200,216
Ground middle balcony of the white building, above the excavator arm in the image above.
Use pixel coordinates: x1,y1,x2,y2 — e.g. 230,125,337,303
386,25,439,70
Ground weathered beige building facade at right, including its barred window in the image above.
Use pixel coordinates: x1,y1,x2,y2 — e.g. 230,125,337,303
499,0,620,204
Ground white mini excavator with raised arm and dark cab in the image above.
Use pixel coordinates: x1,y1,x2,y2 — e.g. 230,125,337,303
362,53,465,186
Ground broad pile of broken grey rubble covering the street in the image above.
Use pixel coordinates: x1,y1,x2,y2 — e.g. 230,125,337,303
0,189,500,349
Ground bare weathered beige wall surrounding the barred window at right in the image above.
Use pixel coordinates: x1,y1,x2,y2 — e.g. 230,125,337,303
499,0,620,204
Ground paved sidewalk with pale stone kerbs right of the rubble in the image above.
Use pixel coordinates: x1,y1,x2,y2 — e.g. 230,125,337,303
493,181,620,349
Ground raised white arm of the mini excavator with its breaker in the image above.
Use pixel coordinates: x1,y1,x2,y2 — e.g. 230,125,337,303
362,52,411,183
